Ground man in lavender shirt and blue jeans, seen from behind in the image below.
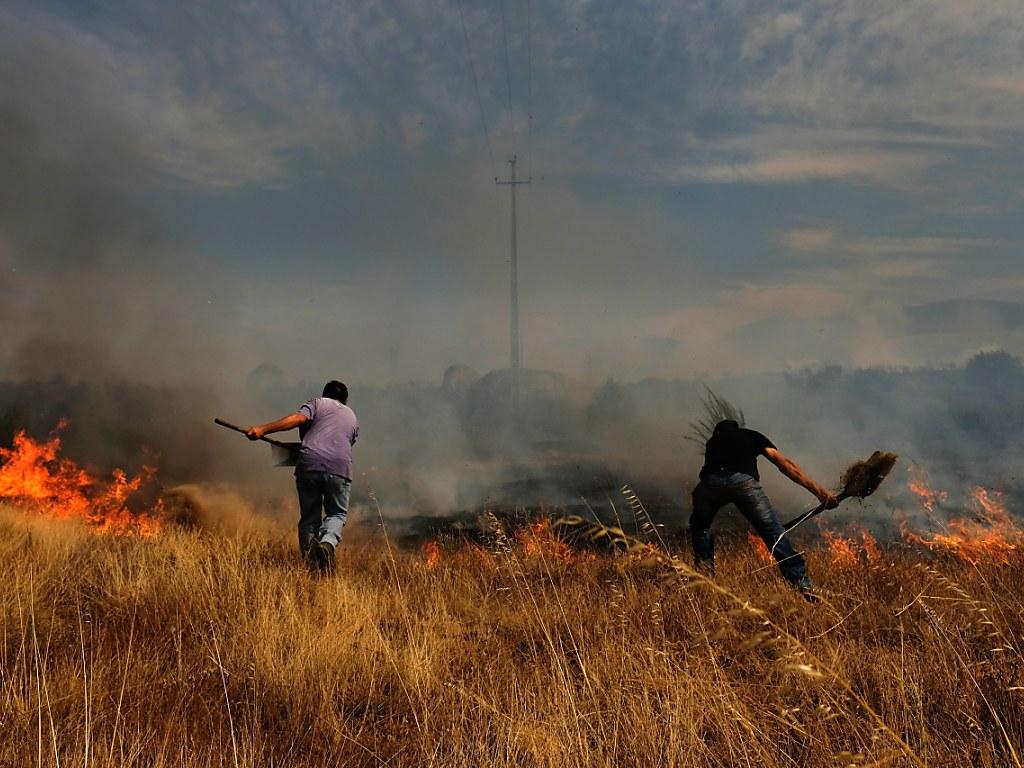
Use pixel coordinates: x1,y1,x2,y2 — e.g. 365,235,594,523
246,381,359,571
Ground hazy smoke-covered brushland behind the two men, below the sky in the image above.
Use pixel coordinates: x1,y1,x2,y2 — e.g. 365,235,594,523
0,351,1024,535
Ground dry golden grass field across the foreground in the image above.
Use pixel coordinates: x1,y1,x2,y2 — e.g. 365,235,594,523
0,499,1024,768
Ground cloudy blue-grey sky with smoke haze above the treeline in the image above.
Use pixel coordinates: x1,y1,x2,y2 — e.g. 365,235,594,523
0,0,1024,384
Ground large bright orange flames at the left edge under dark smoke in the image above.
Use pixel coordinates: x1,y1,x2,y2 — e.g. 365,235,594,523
0,422,162,537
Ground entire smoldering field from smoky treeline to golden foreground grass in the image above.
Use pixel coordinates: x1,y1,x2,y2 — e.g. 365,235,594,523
6,354,1024,768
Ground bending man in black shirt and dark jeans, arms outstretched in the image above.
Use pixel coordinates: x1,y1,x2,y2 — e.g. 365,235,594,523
690,420,839,592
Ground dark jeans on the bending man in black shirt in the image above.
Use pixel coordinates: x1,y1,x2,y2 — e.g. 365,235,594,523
690,472,808,585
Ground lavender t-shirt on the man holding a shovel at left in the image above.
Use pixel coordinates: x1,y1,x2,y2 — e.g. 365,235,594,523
295,397,359,479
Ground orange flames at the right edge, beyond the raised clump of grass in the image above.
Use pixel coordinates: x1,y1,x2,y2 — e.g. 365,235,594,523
900,487,1024,565
